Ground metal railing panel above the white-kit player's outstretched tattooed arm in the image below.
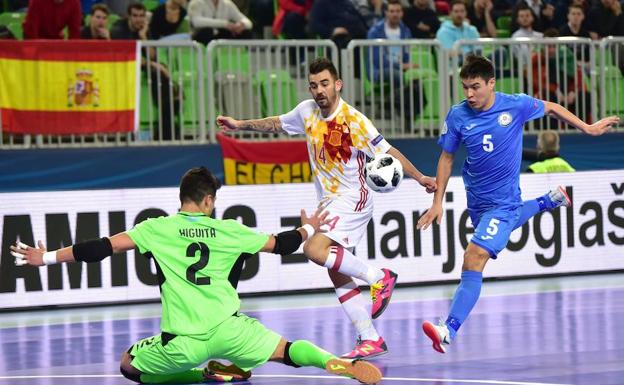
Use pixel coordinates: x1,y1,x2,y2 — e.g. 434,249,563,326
206,40,338,141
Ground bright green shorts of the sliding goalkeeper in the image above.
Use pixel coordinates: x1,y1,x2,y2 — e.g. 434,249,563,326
129,313,281,374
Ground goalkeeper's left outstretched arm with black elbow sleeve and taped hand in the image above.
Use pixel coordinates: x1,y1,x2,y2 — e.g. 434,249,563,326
11,233,135,266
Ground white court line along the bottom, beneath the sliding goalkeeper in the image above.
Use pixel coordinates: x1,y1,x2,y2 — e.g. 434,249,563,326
0,374,572,385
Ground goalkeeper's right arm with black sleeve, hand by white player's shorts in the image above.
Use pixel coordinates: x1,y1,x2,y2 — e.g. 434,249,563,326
260,207,329,254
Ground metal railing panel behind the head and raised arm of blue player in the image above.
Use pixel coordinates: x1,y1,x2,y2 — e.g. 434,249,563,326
451,37,598,132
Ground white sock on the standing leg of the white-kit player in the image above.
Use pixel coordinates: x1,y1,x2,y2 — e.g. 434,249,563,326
336,281,379,341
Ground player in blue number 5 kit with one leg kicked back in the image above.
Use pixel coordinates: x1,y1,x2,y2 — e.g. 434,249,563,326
417,56,619,353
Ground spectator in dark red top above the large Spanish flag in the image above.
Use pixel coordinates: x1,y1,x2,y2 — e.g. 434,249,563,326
23,0,82,39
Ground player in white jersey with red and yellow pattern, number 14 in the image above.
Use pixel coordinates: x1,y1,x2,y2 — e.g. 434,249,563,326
217,58,436,359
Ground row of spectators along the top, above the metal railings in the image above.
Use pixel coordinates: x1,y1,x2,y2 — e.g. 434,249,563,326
4,0,624,47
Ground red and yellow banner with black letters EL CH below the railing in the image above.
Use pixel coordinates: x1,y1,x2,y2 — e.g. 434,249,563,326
217,134,312,184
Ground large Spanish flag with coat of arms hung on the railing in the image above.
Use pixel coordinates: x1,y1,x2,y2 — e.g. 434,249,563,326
0,40,140,135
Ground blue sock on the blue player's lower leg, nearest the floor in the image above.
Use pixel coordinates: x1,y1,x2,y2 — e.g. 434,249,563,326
445,270,483,339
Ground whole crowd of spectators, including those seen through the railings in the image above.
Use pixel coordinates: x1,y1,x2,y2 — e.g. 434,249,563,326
0,0,624,135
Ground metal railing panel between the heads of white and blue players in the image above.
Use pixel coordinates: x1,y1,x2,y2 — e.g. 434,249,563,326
342,39,450,138
